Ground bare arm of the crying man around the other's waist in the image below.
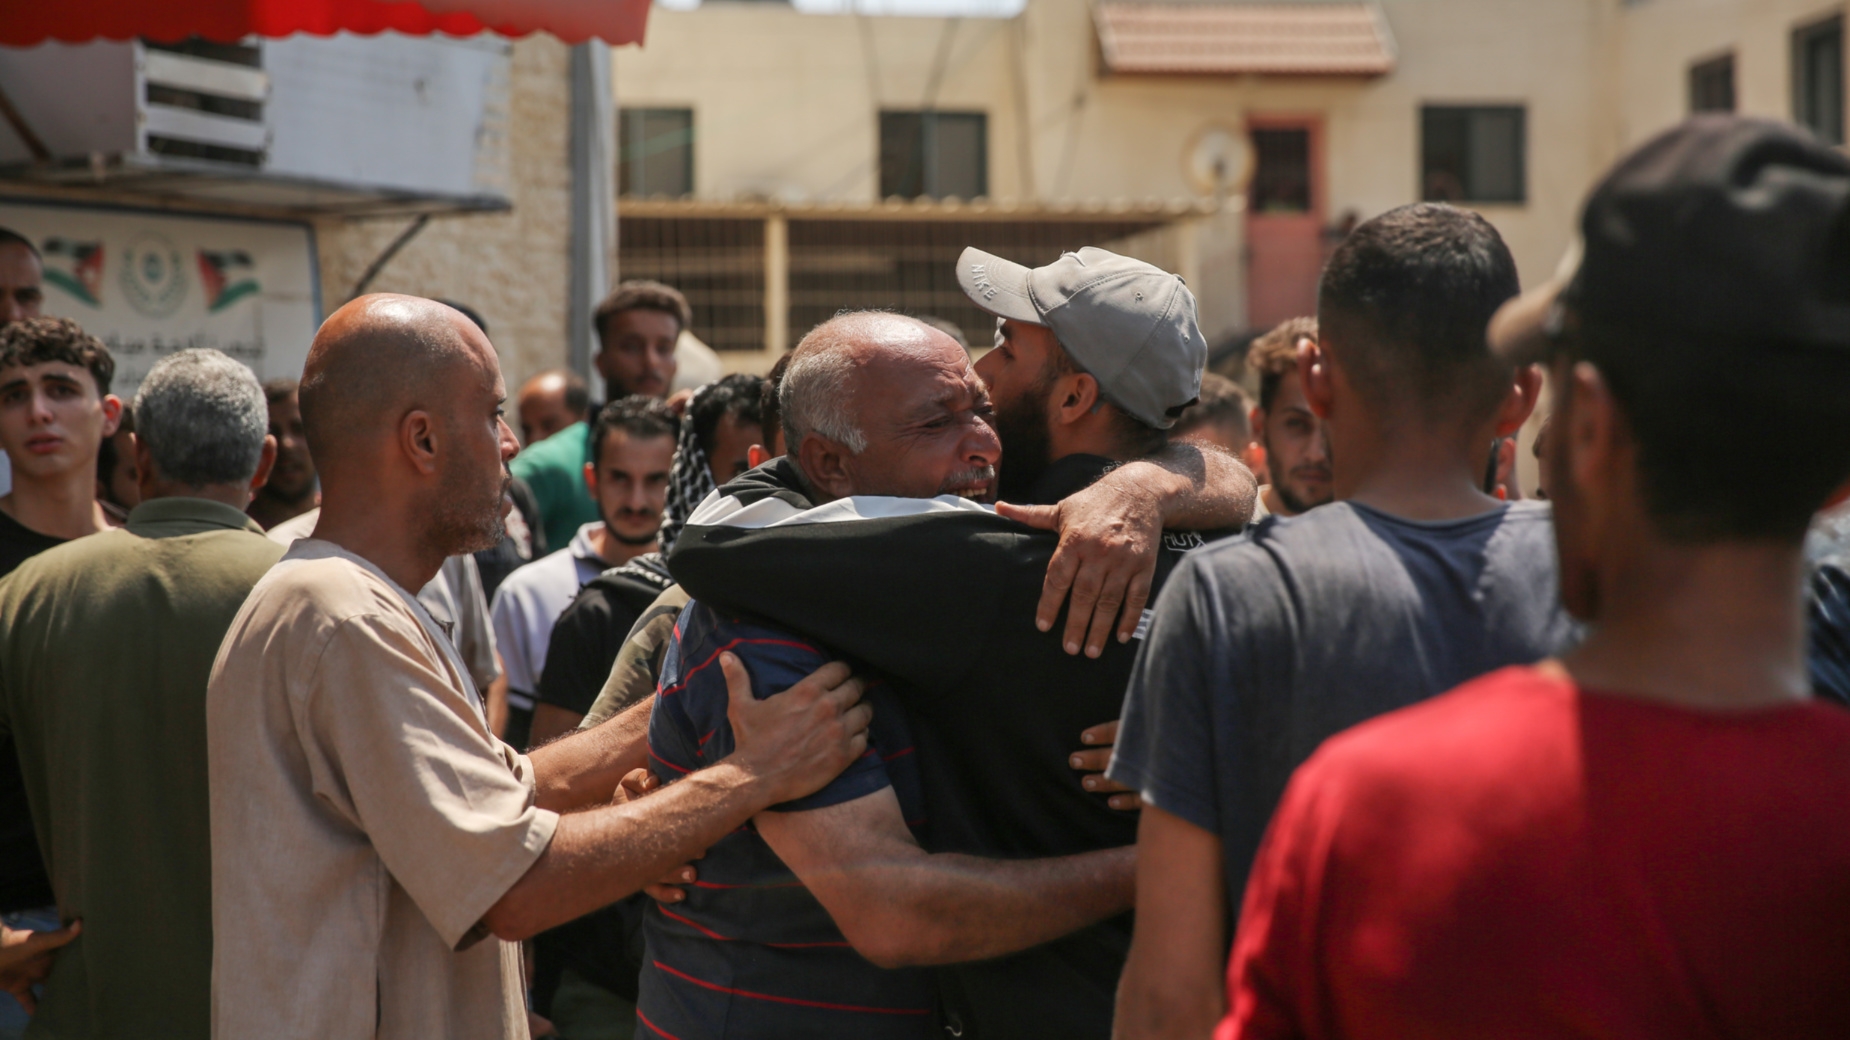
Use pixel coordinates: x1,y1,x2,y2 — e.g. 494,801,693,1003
755,786,1136,968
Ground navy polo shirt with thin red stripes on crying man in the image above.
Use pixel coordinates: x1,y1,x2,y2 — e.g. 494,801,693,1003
636,601,936,1040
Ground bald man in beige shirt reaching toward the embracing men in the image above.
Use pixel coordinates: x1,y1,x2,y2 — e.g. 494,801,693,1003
205,294,871,1040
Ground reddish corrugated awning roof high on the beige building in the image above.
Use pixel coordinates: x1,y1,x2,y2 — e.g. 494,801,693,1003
1093,2,1393,76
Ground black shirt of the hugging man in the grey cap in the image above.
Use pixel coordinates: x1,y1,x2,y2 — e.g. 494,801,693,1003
670,455,1228,1040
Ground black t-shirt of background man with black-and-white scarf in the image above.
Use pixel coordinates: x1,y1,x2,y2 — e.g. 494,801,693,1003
538,553,673,714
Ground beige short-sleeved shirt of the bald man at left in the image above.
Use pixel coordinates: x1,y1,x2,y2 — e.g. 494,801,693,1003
207,539,559,1040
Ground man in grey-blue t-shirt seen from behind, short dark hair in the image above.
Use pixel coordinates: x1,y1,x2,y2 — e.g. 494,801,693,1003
1108,204,1573,1040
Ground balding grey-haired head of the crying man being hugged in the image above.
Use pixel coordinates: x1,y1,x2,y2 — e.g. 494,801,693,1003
777,311,1001,500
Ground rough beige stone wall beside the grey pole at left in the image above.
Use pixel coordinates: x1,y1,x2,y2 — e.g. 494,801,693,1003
316,35,572,389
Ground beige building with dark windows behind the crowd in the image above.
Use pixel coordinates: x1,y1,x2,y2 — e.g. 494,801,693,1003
612,0,1843,375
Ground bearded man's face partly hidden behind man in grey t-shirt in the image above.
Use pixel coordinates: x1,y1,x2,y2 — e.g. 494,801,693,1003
1247,318,1336,520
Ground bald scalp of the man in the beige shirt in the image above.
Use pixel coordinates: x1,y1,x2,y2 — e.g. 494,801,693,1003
300,292,500,476
